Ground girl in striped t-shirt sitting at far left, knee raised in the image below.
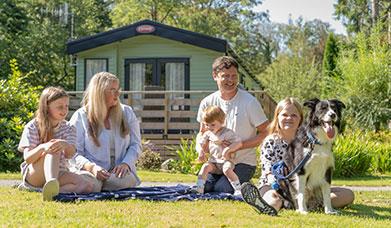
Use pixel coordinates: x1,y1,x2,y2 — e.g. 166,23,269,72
18,87,93,201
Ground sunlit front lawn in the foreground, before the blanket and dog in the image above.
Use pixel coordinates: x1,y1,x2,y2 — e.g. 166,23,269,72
0,187,391,227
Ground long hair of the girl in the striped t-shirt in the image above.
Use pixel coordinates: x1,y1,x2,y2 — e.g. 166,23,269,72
35,87,69,143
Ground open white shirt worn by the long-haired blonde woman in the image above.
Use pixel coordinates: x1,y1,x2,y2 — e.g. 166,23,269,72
69,104,142,185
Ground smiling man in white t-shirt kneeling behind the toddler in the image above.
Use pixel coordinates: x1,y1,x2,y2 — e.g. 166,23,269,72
197,56,269,193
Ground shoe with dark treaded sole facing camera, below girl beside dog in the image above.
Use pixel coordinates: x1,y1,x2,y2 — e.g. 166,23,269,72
242,182,277,216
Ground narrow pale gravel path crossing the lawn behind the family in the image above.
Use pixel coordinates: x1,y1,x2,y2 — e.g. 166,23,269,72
0,180,391,192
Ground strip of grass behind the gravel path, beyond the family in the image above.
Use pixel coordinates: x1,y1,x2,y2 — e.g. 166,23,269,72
0,170,391,186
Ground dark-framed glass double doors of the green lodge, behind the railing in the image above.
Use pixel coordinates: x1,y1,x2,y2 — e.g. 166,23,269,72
125,58,190,133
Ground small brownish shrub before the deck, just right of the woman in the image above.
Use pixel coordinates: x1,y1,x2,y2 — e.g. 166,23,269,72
137,140,162,170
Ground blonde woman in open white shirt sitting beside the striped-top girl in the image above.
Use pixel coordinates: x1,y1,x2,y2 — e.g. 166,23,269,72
70,72,141,191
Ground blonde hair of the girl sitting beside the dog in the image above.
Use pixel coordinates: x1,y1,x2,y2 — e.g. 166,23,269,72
268,97,303,134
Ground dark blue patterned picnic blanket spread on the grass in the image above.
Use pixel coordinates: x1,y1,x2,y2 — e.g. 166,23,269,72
55,184,242,202
